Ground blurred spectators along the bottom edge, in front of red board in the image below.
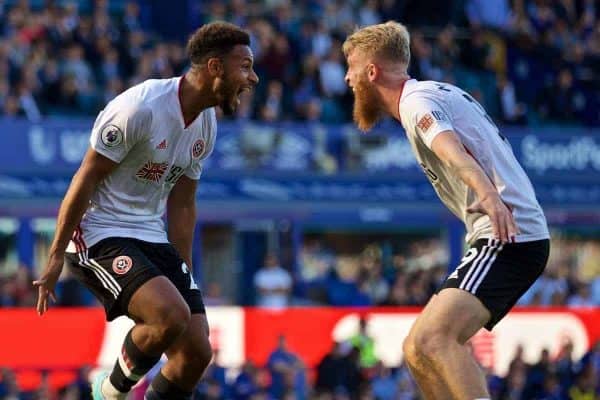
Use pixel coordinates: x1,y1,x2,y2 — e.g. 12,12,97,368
0,330,600,400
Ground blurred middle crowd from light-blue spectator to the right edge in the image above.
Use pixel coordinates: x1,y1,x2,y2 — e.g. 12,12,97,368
254,235,600,308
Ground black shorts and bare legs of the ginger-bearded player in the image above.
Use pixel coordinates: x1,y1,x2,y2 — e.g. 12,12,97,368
405,239,549,399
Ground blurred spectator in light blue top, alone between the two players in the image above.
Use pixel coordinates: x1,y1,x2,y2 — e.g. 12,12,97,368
254,254,292,308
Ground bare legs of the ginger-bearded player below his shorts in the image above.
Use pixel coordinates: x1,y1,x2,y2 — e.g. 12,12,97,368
404,288,490,399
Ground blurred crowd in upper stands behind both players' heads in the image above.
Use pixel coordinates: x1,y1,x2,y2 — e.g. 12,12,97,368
0,0,600,124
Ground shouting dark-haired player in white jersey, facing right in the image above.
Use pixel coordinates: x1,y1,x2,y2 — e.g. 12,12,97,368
34,22,258,400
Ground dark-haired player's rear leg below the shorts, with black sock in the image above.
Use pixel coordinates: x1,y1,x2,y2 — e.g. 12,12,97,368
146,314,212,400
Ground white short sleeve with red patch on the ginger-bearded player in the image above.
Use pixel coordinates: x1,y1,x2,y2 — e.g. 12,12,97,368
400,95,453,148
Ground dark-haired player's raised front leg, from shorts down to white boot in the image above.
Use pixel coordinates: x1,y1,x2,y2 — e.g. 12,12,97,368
66,238,190,399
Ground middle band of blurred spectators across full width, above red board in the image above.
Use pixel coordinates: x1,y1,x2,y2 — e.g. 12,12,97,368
0,232,600,308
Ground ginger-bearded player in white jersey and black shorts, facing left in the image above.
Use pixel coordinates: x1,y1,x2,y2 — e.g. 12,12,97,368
343,22,550,400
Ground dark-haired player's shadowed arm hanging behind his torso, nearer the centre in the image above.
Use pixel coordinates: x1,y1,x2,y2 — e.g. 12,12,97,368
167,175,198,270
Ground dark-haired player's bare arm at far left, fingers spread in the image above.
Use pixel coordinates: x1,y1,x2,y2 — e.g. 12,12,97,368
33,149,117,315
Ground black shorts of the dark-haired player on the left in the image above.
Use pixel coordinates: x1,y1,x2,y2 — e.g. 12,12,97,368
65,237,205,321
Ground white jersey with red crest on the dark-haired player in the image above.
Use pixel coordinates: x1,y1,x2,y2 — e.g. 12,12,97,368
67,77,217,252
